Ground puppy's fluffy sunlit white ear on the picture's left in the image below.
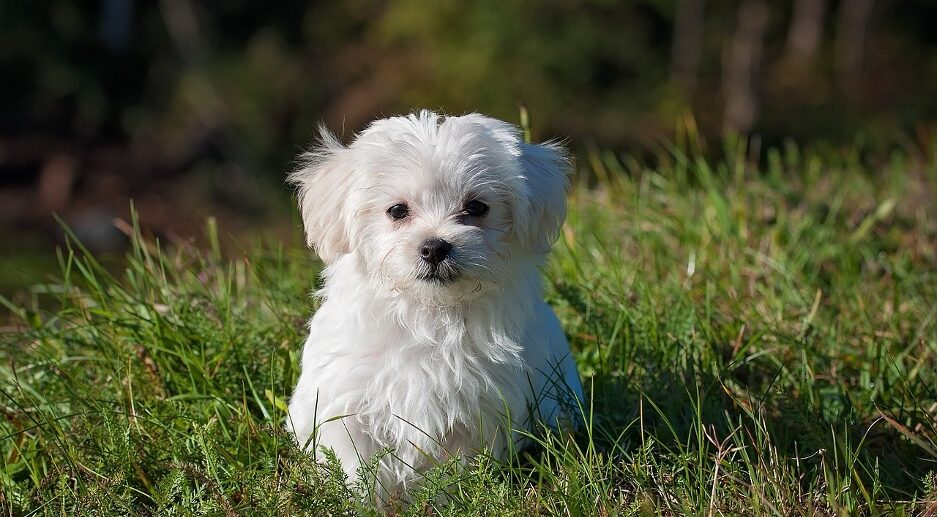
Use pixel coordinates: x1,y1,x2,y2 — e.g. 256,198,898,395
287,126,353,264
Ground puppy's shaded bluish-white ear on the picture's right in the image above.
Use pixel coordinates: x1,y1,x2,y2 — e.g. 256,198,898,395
514,142,571,253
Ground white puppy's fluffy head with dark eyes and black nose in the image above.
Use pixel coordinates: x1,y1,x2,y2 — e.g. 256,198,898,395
290,111,569,305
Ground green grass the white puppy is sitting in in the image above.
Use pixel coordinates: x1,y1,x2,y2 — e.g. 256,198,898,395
0,135,936,515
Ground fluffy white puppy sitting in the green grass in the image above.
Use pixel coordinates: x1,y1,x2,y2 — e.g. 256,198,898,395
287,111,582,493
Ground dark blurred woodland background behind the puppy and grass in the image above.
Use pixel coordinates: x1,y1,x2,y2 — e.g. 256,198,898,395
0,0,936,293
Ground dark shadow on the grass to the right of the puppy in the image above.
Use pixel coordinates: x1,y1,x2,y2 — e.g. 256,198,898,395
498,276,936,513
